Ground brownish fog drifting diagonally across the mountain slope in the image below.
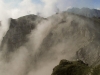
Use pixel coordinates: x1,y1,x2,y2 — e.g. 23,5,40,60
0,13,99,75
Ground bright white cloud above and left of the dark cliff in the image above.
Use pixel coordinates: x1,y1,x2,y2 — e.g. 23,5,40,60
0,0,63,44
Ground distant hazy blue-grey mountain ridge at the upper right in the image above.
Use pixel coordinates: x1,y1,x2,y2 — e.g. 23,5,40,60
67,8,100,17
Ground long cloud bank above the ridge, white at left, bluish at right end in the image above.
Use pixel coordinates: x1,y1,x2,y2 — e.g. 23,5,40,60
0,0,100,45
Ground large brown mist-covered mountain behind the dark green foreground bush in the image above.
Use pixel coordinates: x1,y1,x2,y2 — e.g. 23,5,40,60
0,12,100,75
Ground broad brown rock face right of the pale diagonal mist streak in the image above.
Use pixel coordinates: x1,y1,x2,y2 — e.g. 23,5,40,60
35,13,100,65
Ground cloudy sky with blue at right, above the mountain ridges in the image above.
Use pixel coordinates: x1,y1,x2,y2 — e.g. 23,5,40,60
0,0,100,18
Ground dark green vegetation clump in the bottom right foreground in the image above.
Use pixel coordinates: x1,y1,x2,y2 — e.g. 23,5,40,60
52,60,100,75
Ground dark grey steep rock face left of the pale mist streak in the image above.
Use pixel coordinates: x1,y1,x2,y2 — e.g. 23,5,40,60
1,15,43,52
